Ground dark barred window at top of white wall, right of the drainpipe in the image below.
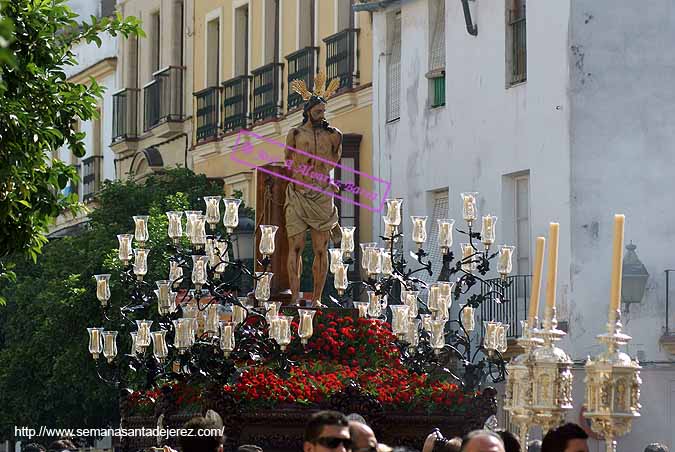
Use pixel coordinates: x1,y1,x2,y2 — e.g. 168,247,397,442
506,0,527,85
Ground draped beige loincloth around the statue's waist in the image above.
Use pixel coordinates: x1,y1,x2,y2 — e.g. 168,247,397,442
284,183,340,241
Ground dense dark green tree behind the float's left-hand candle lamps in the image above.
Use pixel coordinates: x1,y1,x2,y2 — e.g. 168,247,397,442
0,169,251,438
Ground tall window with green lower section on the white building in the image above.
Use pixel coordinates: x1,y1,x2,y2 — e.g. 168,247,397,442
427,0,445,107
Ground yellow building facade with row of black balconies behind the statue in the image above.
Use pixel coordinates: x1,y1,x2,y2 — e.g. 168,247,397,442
191,0,373,247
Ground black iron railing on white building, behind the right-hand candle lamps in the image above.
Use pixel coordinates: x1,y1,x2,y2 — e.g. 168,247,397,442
476,275,532,337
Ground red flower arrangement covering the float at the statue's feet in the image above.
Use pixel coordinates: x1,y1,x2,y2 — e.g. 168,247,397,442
129,311,479,414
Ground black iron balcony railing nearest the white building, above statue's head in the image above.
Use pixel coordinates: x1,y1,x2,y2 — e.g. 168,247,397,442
323,28,359,89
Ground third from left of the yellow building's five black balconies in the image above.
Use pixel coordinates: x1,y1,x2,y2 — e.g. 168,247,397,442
251,63,284,123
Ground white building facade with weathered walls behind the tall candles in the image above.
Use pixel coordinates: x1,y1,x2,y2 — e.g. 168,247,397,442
368,0,675,452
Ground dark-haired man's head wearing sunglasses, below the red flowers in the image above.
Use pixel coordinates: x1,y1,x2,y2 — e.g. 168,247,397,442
303,411,352,452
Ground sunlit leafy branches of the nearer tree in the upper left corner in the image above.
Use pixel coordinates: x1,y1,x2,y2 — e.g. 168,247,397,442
0,0,143,290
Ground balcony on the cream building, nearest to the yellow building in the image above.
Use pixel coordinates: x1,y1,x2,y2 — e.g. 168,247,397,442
143,66,184,138
